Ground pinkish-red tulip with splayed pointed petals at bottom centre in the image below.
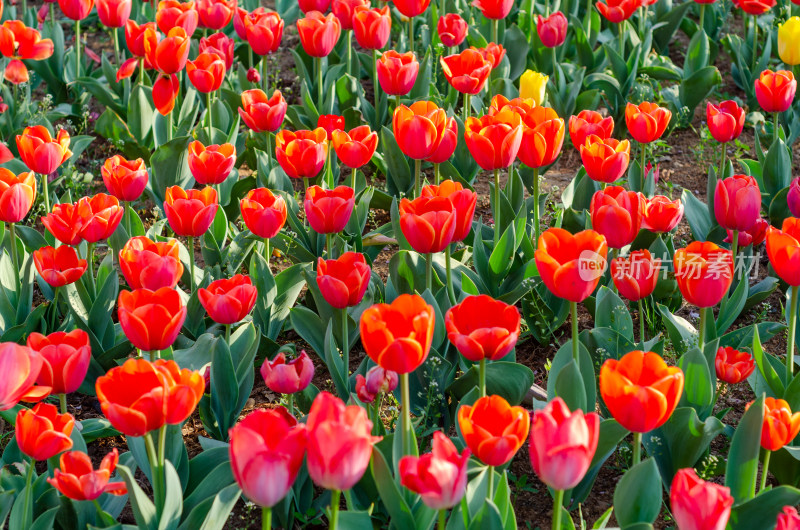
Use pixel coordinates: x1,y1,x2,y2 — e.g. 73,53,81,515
398,431,470,510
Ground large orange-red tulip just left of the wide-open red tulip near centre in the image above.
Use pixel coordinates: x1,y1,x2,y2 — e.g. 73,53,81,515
360,294,436,374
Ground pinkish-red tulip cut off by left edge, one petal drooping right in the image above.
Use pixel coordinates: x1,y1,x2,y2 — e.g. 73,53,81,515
0,342,51,410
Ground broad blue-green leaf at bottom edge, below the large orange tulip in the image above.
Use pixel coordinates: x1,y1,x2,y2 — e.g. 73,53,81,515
614,458,661,528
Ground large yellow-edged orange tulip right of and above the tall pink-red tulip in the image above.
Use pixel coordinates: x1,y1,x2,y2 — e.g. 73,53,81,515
600,350,683,433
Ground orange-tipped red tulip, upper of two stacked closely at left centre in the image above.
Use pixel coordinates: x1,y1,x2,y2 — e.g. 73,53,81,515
119,236,183,291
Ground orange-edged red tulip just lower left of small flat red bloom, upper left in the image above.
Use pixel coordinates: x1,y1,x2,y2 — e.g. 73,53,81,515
275,127,328,178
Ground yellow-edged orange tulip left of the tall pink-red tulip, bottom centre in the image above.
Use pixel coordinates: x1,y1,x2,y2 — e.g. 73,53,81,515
458,396,531,466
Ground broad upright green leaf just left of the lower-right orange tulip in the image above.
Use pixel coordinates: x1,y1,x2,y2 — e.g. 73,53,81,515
725,396,764,505
